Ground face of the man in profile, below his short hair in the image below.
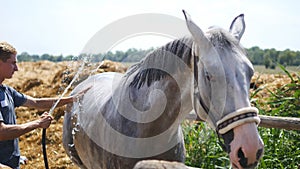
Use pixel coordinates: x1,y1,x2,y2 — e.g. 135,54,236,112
0,54,18,82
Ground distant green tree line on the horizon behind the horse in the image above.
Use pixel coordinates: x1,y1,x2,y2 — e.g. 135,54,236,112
18,46,300,68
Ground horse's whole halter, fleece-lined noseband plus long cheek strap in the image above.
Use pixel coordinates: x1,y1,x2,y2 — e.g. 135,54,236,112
192,44,260,140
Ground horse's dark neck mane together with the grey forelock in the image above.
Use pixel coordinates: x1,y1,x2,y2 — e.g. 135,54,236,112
126,28,246,88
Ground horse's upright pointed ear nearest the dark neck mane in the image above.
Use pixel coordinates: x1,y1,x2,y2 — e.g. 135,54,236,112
182,10,212,51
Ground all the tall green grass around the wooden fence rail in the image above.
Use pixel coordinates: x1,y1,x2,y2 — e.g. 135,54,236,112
183,65,300,169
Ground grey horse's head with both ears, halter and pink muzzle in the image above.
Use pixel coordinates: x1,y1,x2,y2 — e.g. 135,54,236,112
184,12,263,168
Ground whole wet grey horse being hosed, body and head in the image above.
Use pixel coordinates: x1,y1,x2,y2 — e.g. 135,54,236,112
63,11,263,169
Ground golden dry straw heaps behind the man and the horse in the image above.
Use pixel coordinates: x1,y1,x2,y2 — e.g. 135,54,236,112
4,61,296,169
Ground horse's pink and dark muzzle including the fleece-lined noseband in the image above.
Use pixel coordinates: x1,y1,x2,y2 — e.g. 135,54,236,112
216,107,264,169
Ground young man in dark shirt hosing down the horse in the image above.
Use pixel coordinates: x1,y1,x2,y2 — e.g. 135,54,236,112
0,42,88,169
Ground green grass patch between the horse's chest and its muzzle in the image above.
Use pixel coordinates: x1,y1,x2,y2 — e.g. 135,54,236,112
183,121,230,169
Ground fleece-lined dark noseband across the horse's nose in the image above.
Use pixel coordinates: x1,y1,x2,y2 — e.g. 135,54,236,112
216,107,260,134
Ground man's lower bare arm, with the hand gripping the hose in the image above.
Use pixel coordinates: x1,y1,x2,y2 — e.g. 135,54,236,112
0,113,52,141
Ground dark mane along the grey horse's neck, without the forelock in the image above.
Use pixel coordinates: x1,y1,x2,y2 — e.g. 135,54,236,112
126,38,193,88
